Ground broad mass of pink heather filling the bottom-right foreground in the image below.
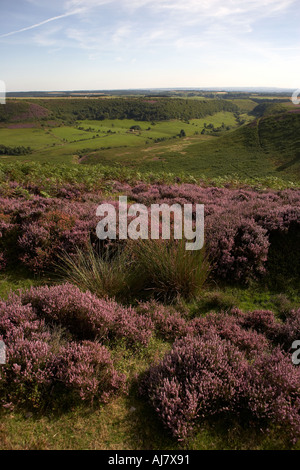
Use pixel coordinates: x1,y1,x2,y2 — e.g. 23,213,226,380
141,304,300,441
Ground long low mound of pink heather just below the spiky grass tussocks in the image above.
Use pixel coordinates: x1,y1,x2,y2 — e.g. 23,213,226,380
12,283,153,345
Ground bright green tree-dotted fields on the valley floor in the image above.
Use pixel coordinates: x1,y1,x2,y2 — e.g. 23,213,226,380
0,111,245,163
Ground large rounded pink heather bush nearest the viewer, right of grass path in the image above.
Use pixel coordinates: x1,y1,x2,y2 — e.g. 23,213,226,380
141,335,248,440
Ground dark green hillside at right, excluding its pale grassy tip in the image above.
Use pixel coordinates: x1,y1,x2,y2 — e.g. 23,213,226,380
129,113,300,181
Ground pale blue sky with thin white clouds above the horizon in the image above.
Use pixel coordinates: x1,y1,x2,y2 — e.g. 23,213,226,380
0,0,300,91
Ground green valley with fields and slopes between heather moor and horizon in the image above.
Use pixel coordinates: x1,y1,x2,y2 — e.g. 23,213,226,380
0,98,299,182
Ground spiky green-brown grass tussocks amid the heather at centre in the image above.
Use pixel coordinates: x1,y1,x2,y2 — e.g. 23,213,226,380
59,239,210,302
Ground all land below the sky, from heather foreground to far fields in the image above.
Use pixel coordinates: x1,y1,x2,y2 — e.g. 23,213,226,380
0,92,300,450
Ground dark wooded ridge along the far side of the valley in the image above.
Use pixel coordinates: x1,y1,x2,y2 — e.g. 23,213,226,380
0,97,239,122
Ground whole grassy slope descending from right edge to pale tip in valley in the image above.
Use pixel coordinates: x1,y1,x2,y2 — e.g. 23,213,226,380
85,113,300,181
